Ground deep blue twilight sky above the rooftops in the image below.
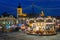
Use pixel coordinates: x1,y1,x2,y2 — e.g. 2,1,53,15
0,0,60,16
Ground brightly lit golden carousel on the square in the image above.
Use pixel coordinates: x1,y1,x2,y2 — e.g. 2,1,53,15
26,17,57,35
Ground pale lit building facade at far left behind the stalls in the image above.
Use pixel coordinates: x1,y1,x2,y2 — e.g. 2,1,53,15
0,15,16,24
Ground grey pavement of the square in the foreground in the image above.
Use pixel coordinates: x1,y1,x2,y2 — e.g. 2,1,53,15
0,32,60,40
